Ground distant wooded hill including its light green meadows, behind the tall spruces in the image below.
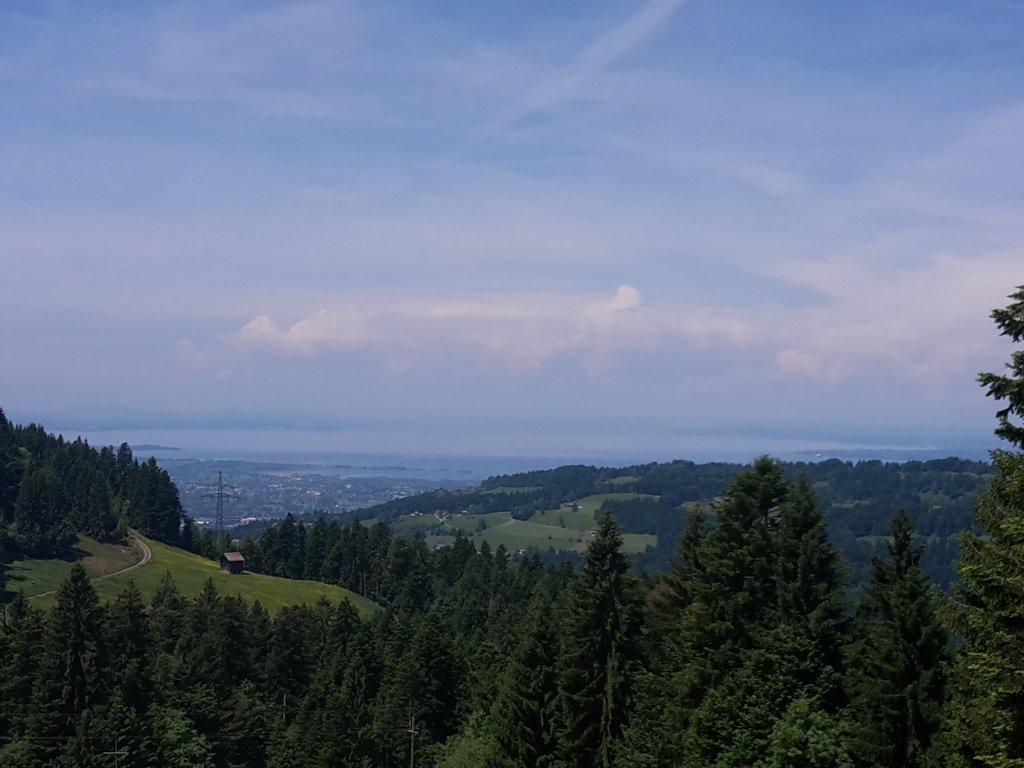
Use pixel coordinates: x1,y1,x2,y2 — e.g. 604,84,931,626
362,457,992,585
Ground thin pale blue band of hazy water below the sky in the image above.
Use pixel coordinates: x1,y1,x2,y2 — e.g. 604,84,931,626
15,420,997,476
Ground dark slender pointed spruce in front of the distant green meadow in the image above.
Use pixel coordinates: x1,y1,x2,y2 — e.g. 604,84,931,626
559,513,642,768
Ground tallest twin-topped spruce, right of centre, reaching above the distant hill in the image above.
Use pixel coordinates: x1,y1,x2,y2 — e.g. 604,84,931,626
666,475,845,768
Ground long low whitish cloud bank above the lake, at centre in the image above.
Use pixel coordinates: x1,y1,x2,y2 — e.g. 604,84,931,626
236,285,746,373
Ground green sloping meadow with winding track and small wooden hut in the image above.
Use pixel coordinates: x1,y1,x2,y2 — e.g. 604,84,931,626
8,539,376,615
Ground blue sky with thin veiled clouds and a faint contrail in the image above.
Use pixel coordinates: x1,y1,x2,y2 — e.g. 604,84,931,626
0,0,1024,450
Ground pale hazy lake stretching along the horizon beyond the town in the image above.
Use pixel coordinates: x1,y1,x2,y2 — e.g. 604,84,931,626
56,428,988,481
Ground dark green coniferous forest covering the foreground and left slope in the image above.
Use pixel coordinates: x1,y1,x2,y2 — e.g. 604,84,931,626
0,287,1024,768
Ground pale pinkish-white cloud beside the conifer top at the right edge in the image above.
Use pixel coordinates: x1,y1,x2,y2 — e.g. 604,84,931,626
758,247,1024,386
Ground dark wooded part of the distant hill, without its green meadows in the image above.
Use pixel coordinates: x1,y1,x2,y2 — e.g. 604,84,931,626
360,457,993,586
